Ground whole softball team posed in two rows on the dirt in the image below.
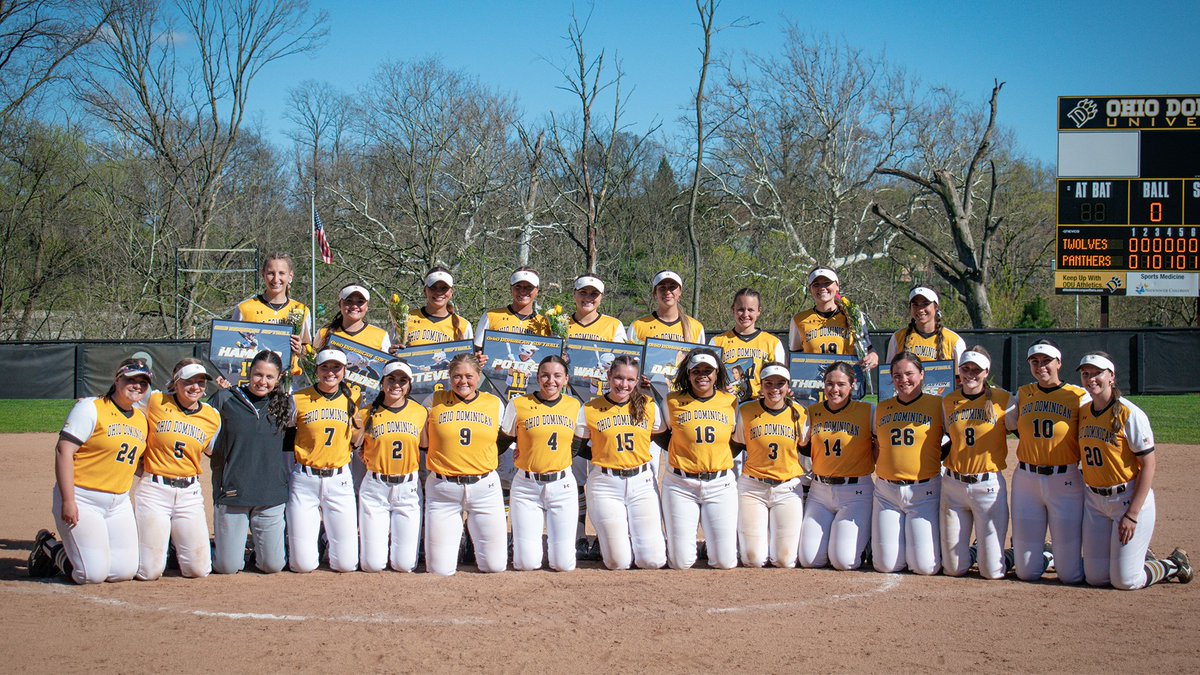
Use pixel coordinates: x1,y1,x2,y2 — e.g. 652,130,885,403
29,253,1193,590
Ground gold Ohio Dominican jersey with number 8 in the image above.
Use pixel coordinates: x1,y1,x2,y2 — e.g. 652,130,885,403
942,387,1013,473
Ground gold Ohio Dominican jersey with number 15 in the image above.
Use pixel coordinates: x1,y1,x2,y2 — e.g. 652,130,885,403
575,394,664,468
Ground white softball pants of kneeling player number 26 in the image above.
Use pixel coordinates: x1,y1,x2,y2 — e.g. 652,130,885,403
871,476,942,574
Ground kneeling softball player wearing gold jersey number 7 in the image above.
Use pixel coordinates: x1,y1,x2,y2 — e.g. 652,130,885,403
287,350,359,573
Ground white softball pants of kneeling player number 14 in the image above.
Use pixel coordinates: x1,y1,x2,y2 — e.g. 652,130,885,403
800,476,875,569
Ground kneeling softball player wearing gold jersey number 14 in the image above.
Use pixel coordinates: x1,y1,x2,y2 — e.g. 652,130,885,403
800,363,875,569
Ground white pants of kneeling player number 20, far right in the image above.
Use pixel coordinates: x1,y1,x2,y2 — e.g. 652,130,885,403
1080,479,1156,591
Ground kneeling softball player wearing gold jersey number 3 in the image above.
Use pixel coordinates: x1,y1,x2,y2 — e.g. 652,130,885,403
733,362,809,567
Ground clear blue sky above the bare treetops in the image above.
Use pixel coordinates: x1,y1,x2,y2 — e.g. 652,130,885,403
243,0,1200,166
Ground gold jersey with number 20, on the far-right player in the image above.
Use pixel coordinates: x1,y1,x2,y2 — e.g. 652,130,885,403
1079,398,1154,488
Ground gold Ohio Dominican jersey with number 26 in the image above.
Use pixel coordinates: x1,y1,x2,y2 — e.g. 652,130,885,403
875,394,943,480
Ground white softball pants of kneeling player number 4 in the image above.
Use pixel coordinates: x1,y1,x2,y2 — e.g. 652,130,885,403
509,470,580,572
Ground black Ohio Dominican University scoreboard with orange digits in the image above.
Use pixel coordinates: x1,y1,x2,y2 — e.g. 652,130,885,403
1055,96,1200,297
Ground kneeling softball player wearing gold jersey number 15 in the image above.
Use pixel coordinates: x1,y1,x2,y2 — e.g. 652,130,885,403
572,356,667,569
